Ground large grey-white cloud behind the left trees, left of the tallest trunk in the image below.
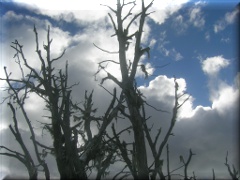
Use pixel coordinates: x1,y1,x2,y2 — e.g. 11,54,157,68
0,16,120,178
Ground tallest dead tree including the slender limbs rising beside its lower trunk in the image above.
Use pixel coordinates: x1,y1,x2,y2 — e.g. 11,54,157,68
95,0,193,179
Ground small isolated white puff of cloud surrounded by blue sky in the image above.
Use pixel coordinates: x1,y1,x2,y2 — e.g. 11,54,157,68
202,56,229,76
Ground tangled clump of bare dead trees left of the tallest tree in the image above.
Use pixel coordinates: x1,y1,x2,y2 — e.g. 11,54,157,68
0,27,122,179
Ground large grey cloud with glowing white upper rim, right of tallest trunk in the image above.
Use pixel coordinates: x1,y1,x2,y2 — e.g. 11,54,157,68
140,72,239,179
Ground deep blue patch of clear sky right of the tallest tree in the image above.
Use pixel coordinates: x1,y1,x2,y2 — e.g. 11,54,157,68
142,3,238,105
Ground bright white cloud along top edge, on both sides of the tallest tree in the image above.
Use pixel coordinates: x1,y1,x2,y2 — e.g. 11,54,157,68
11,0,189,24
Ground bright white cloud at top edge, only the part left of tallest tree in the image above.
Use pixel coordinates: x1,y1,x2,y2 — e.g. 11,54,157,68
8,0,113,24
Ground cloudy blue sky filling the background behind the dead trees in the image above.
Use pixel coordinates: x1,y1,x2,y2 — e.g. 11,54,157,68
0,0,240,178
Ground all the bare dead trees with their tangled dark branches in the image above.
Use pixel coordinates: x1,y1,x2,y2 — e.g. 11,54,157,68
0,0,238,180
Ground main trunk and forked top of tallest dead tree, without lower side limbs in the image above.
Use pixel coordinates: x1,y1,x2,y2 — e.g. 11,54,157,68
96,0,153,179
